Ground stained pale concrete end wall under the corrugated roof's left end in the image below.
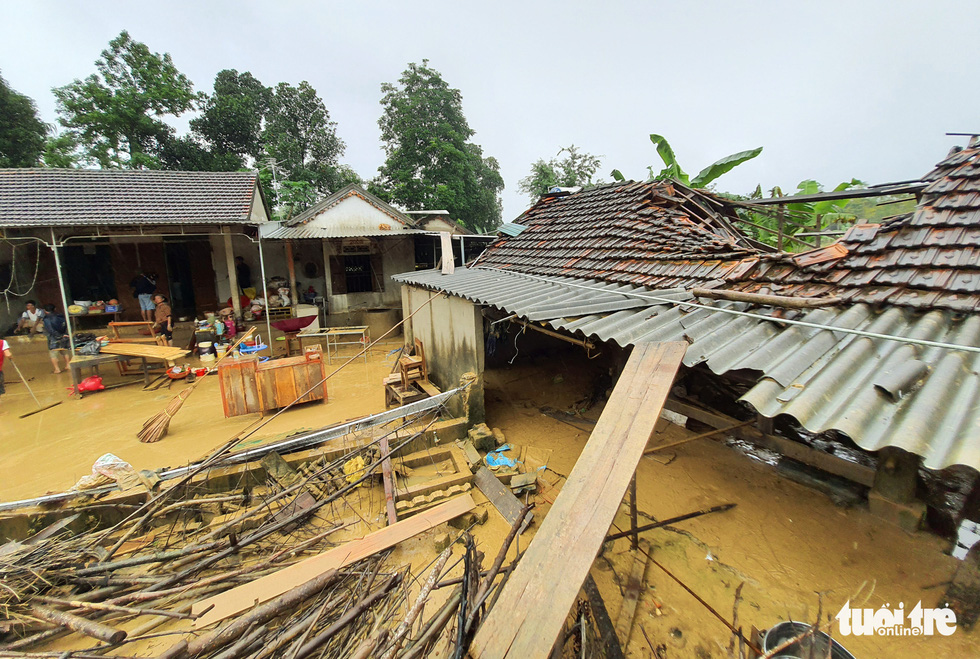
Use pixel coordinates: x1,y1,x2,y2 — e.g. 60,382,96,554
402,284,485,423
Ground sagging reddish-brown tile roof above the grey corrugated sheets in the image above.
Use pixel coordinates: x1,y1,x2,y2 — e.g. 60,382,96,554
476,142,980,311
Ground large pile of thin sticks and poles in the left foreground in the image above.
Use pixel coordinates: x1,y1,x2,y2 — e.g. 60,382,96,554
0,398,523,659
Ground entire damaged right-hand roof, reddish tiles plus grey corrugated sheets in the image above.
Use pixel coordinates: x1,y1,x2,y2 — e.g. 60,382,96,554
396,139,980,470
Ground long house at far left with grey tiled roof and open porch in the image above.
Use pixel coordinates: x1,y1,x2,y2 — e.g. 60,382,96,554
0,168,269,325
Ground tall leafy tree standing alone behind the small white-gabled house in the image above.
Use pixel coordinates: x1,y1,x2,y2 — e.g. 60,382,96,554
371,60,504,232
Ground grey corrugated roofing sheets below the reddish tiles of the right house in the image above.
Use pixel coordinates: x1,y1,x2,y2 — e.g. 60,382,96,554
395,268,980,469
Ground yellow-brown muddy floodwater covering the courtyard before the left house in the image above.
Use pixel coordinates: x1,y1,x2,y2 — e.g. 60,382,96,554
0,335,401,501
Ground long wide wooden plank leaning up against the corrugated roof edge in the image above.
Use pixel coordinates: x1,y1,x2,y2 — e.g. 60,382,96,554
470,342,687,659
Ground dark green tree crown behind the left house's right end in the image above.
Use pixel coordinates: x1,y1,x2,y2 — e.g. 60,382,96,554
191,69,272,167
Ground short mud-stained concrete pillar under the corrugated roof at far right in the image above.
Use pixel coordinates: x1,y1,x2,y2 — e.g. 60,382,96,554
868,447,926,533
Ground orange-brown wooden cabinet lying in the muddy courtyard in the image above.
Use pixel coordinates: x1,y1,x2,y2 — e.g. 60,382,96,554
218,346,327,417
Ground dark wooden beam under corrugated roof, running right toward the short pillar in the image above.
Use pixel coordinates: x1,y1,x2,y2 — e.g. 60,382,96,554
664,398,875,487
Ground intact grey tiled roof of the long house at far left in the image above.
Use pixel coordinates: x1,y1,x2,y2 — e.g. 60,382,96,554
0,168,262,227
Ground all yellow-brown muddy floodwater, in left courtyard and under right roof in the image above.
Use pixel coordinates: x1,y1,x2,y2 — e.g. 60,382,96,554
0,332,980,659
